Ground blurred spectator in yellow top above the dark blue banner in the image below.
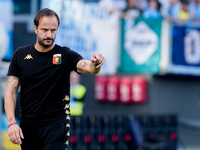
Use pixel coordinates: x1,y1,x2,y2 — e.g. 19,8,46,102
179,0,189,21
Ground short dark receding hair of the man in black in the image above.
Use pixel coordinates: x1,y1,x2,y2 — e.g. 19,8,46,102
34,8,60,27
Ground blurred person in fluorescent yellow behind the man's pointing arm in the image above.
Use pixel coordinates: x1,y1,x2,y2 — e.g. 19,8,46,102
70,72,86,116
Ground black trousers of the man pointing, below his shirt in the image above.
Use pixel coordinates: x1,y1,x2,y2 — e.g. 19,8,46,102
20,123,69,150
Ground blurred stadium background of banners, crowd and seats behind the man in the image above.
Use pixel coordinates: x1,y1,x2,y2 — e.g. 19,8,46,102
0,0,200,150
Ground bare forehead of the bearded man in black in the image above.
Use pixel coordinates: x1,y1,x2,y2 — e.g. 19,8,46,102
38,16,58,28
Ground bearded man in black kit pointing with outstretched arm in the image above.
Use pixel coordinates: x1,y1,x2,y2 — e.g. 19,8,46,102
4,8,105,150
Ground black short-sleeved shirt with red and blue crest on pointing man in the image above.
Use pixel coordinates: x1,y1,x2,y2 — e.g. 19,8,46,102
7,45,83,126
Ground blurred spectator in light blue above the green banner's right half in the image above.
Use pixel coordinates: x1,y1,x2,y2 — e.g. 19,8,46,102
142,0,161,18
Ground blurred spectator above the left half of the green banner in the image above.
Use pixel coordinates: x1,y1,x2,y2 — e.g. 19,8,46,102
121,0,141,18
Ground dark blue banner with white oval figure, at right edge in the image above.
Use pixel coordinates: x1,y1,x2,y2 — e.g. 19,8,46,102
167,24,200,76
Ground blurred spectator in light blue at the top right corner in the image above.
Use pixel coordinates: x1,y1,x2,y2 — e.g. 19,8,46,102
188,0,200,21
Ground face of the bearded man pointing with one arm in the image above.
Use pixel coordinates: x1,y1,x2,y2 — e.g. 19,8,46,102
34,16,58,48
